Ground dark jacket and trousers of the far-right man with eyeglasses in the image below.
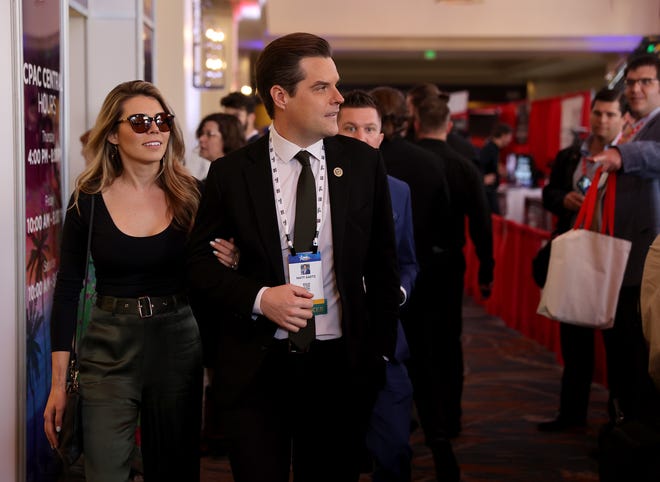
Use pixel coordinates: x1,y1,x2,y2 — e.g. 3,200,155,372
603,109,660,419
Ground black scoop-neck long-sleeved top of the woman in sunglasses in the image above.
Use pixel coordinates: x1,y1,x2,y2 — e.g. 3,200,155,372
51,193,187,351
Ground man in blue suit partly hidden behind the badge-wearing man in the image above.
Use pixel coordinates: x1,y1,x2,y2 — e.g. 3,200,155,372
338,90,418,482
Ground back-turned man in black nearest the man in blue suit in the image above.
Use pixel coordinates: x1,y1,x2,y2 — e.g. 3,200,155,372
370,87,460,482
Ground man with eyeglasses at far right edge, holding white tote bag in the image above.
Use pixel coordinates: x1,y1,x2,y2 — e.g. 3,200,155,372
591,54,660,430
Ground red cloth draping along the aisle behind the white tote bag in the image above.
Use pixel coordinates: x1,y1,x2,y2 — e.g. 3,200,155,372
465,215,607,385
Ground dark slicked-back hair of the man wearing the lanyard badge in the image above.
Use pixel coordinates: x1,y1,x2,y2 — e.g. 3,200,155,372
255,32,332,118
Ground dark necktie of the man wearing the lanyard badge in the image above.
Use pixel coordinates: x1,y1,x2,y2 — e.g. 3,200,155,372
289,151,316,352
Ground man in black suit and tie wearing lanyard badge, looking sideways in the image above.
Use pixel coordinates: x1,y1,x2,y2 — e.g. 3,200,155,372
189,33,400,482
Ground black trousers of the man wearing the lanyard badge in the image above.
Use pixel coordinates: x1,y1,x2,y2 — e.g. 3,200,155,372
222,339,371,482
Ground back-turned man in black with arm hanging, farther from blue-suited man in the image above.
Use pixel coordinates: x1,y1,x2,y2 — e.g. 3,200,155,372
413,97,495,448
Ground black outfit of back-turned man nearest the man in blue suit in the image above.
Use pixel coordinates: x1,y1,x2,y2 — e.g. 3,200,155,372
380,138,460,446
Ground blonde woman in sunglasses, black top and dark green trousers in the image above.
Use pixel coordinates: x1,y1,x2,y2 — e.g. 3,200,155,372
44,81,202,482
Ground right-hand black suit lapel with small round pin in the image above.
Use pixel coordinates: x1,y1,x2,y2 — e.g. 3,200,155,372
324,137,352,266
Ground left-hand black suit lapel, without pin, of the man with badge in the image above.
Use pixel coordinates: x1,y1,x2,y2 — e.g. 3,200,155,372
244,136,285,284
